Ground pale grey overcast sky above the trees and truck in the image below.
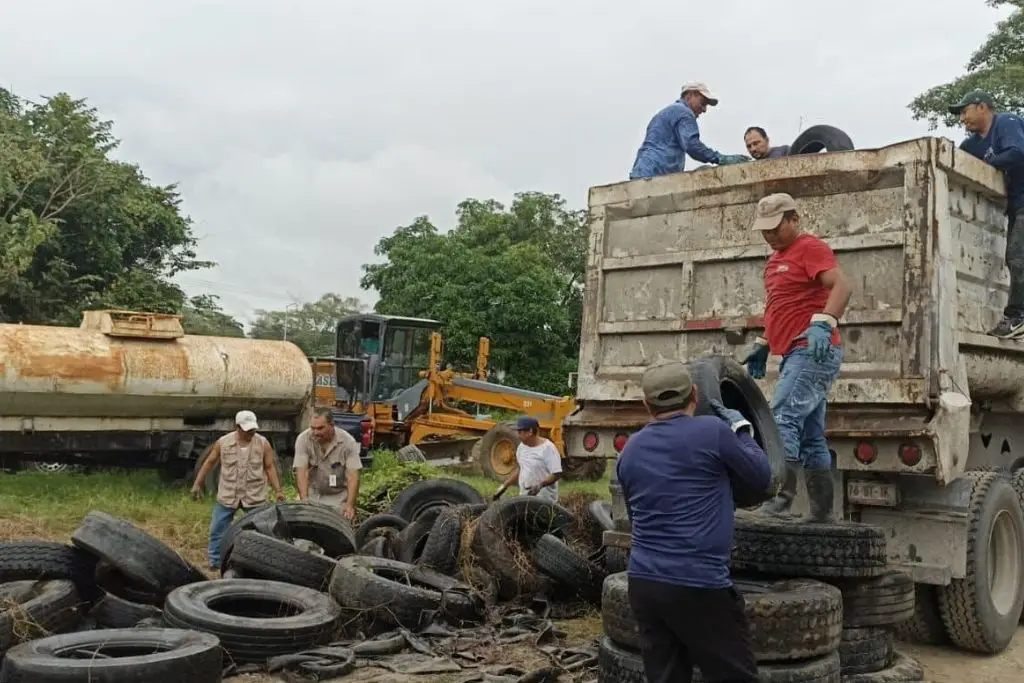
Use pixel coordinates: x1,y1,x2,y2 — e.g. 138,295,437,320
0,0,1006,325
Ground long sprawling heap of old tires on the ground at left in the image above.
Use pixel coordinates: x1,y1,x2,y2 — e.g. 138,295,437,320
0,479,610,683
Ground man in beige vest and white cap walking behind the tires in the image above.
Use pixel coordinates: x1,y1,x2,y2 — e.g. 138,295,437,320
191,411,285,569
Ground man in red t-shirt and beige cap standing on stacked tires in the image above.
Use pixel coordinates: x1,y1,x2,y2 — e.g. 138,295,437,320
743,193,851,521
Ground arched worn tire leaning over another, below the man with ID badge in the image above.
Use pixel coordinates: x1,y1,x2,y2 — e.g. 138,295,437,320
220,501,357,567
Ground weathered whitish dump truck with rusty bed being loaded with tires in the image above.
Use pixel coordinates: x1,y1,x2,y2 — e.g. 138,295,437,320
565,137,1024,652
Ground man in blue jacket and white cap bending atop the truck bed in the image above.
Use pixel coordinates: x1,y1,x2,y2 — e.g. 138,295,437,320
630,83,750,180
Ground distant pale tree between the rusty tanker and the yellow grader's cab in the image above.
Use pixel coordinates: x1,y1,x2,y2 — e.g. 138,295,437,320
250,293,365,356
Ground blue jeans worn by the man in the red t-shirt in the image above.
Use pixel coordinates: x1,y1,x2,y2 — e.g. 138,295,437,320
771,346,843,470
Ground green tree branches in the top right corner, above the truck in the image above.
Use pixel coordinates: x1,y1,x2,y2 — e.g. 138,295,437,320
909,0,1024,129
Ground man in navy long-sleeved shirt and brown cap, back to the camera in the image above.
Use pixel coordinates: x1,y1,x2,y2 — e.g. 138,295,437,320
615,362,771,683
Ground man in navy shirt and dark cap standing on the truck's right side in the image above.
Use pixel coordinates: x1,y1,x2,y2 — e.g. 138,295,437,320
949,90,1024,339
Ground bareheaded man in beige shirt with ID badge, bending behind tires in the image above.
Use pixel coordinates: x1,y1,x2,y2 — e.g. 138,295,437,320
294,408,362,520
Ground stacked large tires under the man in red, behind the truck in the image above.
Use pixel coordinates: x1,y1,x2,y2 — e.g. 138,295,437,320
599,510,925,683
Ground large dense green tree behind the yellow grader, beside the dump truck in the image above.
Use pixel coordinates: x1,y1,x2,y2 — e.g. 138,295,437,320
361,193,587,394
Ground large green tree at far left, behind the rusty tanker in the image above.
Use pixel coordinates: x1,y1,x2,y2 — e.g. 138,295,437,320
0,89,213,325
